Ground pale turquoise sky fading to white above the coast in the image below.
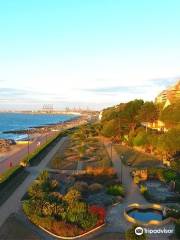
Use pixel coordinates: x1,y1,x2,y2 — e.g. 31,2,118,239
0,0,180,110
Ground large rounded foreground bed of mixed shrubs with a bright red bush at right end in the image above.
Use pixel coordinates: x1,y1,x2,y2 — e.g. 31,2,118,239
23,172,106,237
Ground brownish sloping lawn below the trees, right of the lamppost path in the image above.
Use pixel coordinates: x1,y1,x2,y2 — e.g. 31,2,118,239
115,145,162,167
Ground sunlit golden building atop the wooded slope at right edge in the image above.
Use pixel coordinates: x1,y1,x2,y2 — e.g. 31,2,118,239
155,80,180,108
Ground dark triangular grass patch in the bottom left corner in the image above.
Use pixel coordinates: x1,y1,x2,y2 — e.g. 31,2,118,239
0,214,41,240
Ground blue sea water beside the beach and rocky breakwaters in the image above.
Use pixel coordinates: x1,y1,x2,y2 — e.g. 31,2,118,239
0,113,75,140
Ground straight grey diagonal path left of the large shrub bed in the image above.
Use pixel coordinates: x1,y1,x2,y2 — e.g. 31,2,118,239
0,137,67,226
